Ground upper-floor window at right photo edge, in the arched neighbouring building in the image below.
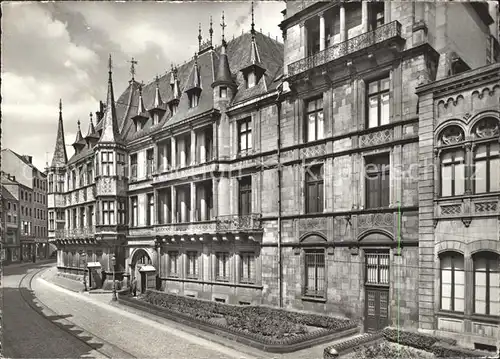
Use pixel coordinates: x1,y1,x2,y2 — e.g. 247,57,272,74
474,142,500,193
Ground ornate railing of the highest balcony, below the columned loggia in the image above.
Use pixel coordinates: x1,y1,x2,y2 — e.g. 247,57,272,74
288,21,401,77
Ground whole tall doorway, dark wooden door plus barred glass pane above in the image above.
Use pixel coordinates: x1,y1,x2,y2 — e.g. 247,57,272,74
364,250,390,333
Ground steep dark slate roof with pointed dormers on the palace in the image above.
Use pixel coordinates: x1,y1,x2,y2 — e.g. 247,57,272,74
69,32,283,152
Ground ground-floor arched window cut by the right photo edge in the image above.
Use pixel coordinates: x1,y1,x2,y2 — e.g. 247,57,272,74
473,252,500,315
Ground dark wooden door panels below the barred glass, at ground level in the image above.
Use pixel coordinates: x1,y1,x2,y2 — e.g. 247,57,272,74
365,287,389,333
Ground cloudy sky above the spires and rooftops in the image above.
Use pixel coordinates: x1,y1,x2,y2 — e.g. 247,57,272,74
1,1,285,170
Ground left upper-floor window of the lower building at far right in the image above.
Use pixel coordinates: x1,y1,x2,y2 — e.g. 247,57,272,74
441,151,465,197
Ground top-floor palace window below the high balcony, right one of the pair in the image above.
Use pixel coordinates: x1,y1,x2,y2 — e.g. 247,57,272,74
366,77,390,128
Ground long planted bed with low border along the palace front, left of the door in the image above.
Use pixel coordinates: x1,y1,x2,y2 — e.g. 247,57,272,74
140,291,355,340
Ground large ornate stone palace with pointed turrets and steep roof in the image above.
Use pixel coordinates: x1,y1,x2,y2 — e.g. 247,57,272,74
48,1,498,344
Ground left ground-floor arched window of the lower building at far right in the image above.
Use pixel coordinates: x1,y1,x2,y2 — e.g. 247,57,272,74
440,253,465,312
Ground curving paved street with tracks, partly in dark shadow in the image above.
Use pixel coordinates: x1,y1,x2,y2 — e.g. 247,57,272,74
4,266,260,359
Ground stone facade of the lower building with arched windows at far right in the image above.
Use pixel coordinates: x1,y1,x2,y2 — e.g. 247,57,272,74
418,64,500,348
